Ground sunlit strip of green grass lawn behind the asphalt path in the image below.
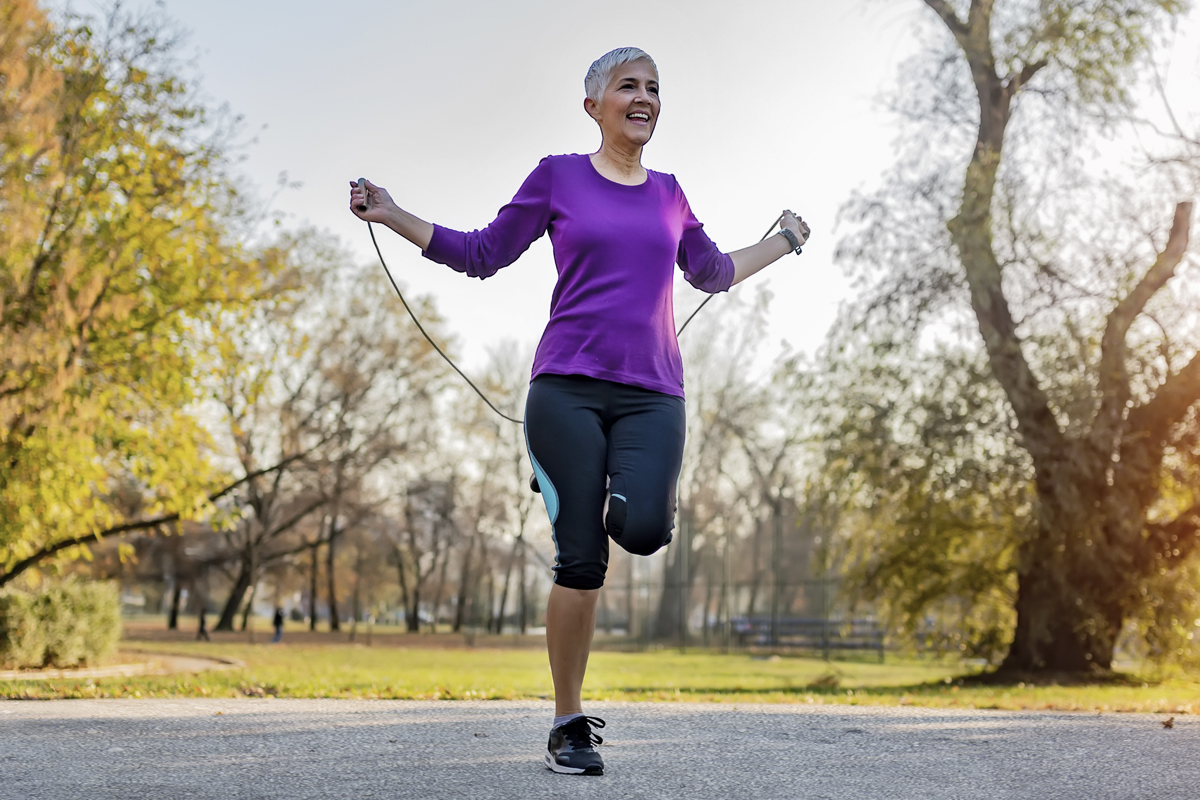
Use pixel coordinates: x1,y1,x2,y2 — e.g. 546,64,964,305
0,642,1200,714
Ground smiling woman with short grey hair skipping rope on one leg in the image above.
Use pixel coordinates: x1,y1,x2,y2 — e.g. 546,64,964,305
350,48,809,775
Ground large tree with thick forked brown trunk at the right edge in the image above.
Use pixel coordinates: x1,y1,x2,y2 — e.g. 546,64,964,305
841,0,1200,670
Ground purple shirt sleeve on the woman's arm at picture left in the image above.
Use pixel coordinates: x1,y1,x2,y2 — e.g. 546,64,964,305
422,158,552,278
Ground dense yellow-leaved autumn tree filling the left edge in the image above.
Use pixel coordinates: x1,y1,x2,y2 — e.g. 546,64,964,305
0,0,278,584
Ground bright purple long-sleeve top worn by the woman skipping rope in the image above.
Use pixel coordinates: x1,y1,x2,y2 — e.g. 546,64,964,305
425,155,733,397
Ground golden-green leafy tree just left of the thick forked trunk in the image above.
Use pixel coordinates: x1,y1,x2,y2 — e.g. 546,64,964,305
808,331,1033,663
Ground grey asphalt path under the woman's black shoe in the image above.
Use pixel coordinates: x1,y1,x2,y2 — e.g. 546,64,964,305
0,699,1200,800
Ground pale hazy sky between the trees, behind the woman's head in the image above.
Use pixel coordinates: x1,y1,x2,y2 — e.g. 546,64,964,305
46,0,1200,369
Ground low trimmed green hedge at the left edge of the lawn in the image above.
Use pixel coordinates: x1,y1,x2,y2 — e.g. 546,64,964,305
0,578,121,668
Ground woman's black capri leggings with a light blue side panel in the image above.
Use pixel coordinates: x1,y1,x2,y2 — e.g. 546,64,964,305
524,374,686,589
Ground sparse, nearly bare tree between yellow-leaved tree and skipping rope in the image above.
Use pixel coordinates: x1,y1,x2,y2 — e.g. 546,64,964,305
212,241,444,630
